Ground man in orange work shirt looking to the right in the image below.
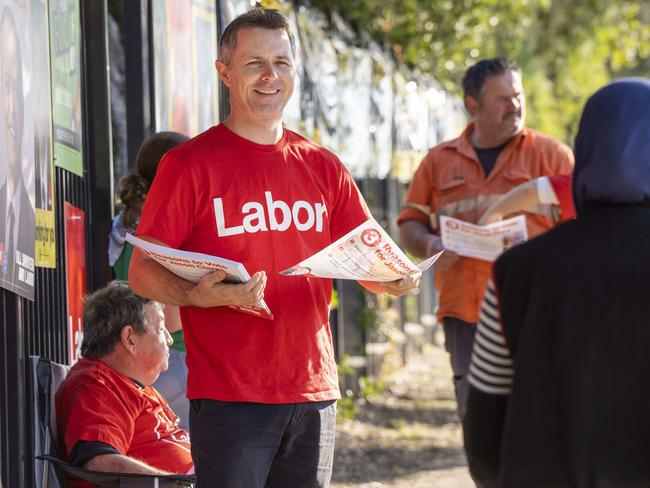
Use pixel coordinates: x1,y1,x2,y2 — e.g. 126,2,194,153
398,58,573,419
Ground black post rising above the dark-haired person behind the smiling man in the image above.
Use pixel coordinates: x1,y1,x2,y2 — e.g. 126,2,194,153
123,0,153,161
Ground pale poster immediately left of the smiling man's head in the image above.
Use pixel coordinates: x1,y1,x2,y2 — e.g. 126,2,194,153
192,0,219,134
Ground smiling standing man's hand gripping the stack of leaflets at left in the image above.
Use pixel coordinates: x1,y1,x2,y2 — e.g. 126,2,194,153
187,270,266,308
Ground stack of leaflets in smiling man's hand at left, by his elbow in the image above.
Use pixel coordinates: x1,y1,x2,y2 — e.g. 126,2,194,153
126,234,273,320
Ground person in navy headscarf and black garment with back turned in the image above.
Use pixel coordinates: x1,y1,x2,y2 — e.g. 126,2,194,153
464,78,650,488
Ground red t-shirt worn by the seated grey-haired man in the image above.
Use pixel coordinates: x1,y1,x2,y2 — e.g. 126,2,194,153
56,358,192,486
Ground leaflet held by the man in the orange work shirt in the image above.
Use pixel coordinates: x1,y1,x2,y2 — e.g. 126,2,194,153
440,215,528,261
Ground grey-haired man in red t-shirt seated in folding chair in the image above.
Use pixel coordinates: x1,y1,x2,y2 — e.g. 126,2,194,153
56,281,193,486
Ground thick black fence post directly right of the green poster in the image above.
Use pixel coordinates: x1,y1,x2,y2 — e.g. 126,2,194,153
81,0,113,291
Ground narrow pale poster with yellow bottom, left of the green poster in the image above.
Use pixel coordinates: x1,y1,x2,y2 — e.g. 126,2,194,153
30,0,56,268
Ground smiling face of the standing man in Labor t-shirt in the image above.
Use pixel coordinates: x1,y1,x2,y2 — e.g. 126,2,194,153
217,27,296,125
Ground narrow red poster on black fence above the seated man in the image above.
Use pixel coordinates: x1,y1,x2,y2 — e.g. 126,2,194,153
64,202,86,365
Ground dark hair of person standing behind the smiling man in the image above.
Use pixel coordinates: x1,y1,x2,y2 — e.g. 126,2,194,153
120,132,189,231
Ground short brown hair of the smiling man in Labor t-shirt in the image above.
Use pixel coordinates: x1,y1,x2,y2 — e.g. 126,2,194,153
219,7,296,64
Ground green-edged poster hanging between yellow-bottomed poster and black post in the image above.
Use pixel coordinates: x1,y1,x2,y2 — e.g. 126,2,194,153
50,0,83,176
